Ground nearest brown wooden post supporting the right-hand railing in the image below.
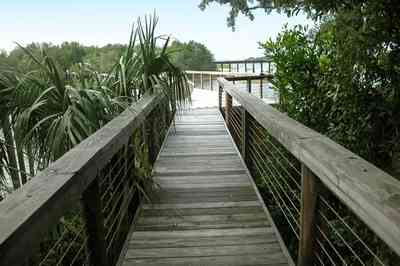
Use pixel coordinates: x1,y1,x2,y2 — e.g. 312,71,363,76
297,164,318,266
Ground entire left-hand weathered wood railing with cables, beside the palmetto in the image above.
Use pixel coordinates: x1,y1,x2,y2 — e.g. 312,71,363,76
0,94,172,266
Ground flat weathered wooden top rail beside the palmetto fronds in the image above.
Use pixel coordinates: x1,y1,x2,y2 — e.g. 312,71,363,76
0,94,165,265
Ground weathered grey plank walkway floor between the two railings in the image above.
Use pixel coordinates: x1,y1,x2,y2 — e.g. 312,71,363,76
120,109,291,266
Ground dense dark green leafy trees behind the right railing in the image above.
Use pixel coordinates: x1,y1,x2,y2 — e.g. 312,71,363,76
200,0,400,174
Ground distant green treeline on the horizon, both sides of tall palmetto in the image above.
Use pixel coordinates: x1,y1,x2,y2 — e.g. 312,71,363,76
0,41,214,73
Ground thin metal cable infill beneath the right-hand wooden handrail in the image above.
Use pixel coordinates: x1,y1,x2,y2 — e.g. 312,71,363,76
219,78,398,265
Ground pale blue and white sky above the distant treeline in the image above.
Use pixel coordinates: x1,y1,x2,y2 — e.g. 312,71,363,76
0,0,311,60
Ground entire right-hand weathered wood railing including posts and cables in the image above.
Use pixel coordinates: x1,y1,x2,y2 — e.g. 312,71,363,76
218,78,400,266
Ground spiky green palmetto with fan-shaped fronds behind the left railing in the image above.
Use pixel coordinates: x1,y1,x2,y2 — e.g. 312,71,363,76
0,15,190,193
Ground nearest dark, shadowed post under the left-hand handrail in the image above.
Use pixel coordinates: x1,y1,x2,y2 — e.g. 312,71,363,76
82,178,108,266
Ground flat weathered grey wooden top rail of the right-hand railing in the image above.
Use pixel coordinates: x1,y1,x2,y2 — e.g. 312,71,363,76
218,78,400,262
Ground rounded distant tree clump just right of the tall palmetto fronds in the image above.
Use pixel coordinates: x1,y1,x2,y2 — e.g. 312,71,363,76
169,41,215,71
